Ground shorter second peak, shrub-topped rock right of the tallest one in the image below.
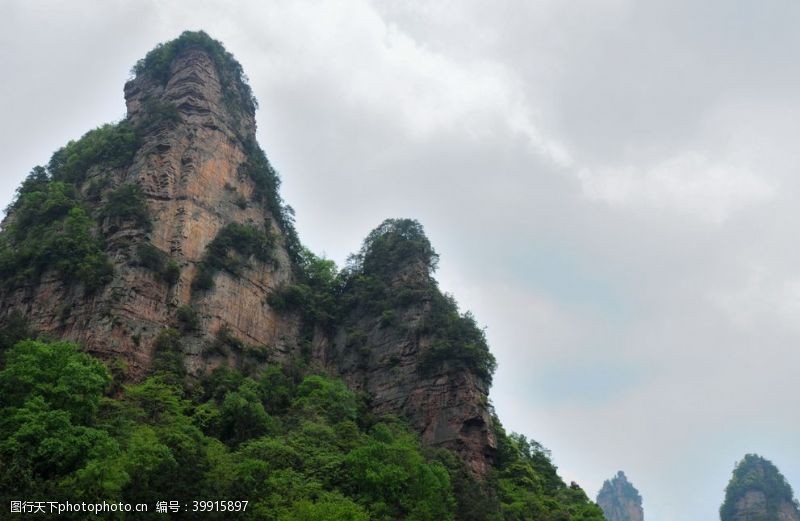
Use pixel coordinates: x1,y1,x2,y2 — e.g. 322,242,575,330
318,220,495,475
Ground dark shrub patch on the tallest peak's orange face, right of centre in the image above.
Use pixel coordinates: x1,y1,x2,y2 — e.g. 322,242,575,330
192,222,275,291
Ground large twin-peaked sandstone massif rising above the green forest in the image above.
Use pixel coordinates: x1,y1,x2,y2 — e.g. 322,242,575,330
0,33,495,475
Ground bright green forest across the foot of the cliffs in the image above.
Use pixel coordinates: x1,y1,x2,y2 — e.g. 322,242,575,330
0,332,602,521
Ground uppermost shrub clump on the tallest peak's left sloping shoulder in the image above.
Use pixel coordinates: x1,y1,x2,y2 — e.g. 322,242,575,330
47,120,141,186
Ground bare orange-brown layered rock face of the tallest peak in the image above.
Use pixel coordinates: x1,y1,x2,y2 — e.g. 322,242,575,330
0,39,296,378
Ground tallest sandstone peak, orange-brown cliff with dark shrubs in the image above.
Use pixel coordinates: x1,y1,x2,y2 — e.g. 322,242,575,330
0,33,296,379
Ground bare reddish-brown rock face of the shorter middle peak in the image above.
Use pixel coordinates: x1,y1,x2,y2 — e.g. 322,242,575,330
317,250,496,476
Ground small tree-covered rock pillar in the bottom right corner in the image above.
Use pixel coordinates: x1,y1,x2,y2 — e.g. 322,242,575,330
720,454,800,521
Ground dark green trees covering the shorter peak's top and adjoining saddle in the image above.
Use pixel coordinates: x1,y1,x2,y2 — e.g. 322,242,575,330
276,219,496,383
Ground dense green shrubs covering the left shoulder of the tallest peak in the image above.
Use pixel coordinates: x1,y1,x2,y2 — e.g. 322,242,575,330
0,117,150,292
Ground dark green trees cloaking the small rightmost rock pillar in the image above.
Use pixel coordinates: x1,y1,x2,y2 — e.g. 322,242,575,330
719,454,798,521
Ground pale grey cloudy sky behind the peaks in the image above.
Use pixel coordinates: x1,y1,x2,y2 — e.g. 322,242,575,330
0,0,800,521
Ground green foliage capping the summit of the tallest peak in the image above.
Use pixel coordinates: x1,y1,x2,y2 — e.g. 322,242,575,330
131,31,258,114
